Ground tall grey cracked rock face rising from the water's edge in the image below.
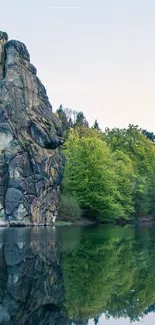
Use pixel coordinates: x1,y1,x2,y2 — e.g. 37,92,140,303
0,40,65,224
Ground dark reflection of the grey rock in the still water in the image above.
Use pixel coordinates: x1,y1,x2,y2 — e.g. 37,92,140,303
0,228,66,325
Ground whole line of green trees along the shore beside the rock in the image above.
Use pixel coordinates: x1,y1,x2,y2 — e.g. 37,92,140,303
56,106,155,222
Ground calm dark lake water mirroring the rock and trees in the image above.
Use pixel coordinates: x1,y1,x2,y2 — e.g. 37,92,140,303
0,226,155,325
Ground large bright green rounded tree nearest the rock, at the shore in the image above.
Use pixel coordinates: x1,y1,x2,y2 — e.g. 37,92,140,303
63,130,133,221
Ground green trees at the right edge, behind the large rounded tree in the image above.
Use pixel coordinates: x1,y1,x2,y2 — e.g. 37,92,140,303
104,125,155,217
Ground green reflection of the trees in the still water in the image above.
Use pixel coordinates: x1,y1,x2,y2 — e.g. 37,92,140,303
59,226,155,325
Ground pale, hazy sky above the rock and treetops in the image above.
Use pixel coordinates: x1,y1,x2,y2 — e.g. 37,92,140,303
0,0,155,132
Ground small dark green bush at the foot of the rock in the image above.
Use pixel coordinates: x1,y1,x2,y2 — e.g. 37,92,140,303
58,195,81,221
